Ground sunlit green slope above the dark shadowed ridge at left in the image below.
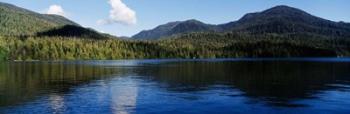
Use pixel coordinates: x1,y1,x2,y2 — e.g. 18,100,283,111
0,2,78,36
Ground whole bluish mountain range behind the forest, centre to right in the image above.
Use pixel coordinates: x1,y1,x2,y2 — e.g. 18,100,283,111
133,5,350,39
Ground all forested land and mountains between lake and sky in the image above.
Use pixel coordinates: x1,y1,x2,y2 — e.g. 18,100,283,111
0,3,350,60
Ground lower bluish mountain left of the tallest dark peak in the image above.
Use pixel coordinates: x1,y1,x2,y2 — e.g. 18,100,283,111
132,19,216,39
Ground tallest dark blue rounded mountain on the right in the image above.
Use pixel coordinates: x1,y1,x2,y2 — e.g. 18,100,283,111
218,6,350,37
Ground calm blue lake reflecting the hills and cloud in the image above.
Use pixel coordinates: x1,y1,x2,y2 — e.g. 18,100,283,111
0,58,350,114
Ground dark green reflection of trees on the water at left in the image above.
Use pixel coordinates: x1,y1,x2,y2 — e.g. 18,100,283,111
0,62,125,106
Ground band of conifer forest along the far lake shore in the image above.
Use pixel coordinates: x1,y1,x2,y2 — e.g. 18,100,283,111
0,33,350,60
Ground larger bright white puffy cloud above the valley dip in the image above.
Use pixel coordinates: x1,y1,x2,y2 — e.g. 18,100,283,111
97,0,137,25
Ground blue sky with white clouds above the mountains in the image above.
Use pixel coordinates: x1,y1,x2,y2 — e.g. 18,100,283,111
0,0,350,36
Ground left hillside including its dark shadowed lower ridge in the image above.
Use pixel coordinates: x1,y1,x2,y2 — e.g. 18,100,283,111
0,2,111,39
